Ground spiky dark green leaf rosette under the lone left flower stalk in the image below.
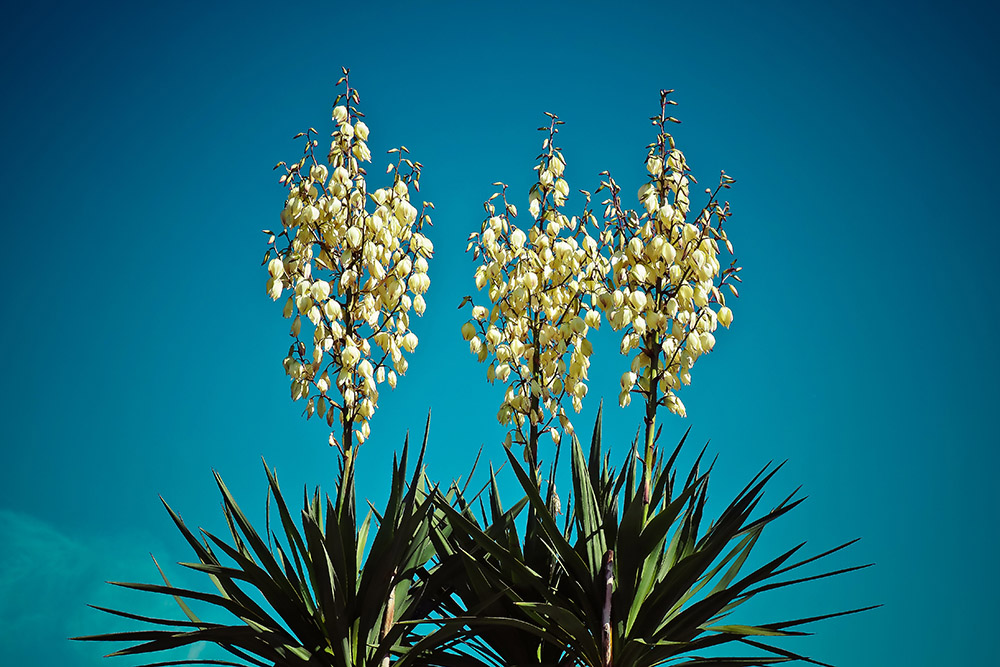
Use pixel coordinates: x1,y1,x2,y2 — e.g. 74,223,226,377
76,422,454,667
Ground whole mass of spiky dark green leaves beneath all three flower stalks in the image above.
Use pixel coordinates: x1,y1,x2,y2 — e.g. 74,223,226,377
79,412,866,667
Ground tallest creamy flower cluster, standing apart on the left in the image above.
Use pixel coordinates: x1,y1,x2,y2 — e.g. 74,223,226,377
264,69,434,451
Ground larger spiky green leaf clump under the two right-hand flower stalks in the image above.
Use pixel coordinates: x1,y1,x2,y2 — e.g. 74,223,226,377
420,412,870,667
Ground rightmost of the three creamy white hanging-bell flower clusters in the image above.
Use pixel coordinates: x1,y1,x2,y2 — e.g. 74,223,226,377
598,91,739,416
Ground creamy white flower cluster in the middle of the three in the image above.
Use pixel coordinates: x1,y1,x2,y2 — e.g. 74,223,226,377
462,114,608,466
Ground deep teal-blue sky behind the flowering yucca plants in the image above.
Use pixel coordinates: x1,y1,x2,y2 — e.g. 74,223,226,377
0,0,1000,667
